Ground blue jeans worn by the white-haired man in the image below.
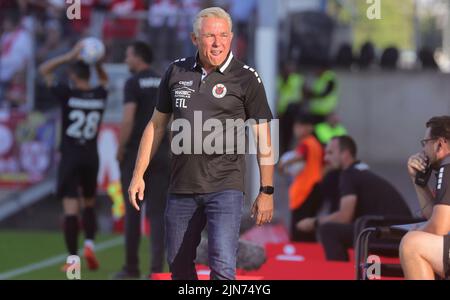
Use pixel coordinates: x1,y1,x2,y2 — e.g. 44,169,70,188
165,190,244,280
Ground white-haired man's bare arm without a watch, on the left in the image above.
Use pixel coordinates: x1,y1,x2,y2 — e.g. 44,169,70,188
128,109,171,210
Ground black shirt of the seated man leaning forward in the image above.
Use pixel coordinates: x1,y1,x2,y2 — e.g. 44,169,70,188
339,162,411,220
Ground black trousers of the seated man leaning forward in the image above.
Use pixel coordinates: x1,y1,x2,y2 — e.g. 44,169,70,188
318,223,355,261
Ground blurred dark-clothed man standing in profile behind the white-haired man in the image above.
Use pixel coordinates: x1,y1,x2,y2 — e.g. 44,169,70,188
114,41,170,279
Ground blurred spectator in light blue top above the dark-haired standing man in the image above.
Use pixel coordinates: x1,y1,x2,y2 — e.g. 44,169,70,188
148,0,181,61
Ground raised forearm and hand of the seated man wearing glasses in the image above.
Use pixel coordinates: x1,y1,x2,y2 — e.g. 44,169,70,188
408,153,433,219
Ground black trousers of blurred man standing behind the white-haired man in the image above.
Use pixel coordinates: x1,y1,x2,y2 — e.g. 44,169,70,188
121,152,169,273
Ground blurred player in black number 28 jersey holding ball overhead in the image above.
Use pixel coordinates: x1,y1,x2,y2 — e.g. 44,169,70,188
39,43,108,270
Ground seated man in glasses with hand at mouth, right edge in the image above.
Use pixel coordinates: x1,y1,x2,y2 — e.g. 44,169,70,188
400,116,450,279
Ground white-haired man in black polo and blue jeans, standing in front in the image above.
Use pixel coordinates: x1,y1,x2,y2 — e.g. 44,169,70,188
129,7,273,279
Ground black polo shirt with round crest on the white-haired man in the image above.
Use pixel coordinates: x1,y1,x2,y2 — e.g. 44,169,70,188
156,52,272,194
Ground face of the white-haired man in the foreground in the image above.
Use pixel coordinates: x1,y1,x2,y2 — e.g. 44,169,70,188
192,17,233,70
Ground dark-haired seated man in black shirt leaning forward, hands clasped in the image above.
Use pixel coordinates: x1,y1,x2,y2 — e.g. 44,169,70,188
297,136,411,261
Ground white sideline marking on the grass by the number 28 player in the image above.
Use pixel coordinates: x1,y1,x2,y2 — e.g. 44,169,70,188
0,237,123,280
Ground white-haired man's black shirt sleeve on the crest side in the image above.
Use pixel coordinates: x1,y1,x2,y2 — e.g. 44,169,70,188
244,71,273,123
